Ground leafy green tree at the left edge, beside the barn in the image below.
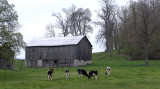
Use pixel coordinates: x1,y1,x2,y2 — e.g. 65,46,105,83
0,0,25,62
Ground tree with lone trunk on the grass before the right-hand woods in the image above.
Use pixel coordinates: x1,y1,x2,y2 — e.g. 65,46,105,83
138,0,160,66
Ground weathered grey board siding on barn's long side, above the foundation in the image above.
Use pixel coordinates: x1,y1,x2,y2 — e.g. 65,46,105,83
26,46,76,60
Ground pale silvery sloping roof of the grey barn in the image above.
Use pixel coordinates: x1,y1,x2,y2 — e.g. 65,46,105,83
27,36,90,47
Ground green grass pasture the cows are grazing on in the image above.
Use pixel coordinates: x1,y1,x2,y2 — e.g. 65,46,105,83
0,53,160,89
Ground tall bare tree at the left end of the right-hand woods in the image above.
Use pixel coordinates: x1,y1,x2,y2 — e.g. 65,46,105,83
95,0,117,56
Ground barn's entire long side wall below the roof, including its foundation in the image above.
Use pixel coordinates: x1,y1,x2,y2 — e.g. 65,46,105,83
26,46,76,67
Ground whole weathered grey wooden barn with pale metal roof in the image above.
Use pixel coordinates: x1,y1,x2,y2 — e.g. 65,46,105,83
25,36,92,67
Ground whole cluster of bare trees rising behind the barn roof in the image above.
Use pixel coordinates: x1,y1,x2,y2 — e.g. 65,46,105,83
47,5,92,37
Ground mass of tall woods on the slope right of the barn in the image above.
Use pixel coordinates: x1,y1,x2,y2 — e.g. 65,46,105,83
94,0,160,66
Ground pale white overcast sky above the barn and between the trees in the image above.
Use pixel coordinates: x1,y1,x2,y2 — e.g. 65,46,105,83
8,0,128,59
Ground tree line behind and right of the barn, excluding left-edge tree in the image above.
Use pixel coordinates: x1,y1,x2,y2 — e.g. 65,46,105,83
46,0,160,66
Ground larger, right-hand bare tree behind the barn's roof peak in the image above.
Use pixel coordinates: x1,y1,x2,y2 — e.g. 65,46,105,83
66,5,93,36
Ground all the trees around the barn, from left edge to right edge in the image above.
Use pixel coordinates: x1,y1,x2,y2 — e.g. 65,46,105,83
0,0,160,66
